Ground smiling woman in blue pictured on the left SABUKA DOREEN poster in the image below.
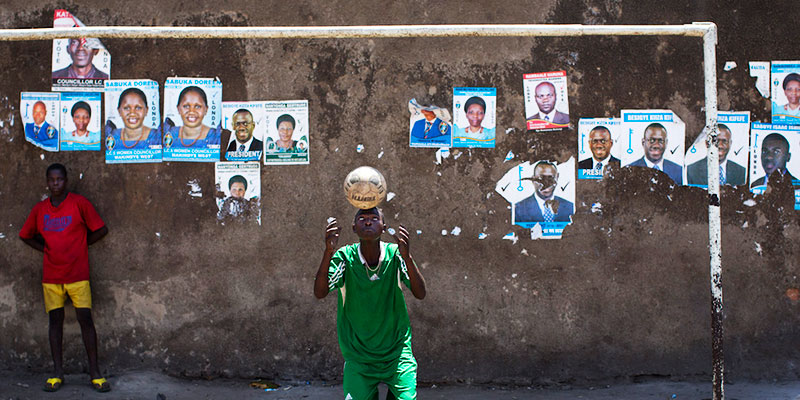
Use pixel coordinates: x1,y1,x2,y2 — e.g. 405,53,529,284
108,87,161,150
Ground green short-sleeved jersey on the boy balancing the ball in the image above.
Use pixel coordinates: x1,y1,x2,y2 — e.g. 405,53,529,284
328,242,411,363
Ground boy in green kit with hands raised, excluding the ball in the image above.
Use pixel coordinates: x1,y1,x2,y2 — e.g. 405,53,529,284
314,207,425,400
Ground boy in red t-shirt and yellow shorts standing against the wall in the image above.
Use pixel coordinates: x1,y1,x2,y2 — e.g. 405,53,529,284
19,164,111,392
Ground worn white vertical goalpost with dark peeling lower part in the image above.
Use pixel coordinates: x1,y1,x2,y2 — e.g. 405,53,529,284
703,24,725,400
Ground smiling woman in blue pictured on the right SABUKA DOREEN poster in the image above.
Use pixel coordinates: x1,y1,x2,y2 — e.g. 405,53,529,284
164,86,221,148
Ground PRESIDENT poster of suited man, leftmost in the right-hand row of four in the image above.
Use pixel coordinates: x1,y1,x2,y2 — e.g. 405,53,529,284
578,118,622,179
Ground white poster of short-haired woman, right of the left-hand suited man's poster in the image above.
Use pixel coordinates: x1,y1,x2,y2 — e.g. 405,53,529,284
264,100,311,165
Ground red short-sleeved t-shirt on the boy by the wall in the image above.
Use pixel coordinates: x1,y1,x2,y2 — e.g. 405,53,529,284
19,192,105,283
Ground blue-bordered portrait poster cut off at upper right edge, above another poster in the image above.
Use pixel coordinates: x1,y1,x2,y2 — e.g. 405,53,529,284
770,61,800,125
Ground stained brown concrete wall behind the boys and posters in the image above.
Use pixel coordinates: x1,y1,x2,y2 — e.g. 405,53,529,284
0,0,800,384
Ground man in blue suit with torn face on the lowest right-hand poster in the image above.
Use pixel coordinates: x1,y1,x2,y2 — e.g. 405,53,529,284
514,161,575,223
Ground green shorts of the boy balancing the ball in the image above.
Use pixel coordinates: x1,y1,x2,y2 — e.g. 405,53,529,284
343,347,417,400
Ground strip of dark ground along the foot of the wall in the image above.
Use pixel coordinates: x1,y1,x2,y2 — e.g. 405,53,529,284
0,371,800,400
